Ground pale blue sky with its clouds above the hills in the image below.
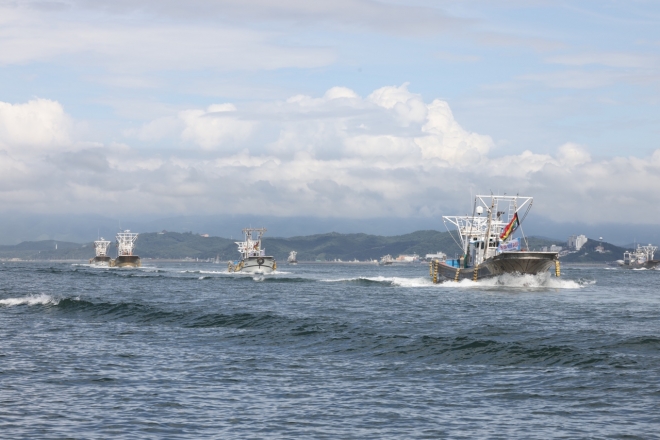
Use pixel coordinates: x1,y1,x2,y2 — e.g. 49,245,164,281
0,0,660,234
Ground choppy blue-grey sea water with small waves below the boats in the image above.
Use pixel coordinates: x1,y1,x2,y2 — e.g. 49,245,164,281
0,263,660,439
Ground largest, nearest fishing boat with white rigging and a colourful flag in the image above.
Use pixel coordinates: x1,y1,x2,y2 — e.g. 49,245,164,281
430,195,560,283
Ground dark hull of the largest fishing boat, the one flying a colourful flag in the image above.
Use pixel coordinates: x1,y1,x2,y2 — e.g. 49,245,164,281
434,252,559,281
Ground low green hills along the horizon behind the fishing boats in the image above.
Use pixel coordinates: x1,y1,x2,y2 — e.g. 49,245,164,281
0,230,624,262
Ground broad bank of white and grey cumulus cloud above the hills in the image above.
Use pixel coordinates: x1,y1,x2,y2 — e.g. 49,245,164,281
0,90,660,227
